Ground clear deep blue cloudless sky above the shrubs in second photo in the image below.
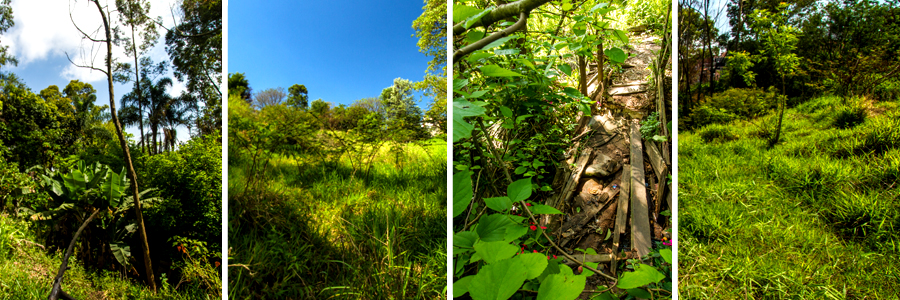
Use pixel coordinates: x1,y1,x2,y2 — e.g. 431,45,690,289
228,0,431,108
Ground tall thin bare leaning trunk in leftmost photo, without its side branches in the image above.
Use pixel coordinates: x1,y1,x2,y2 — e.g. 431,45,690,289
91,0,156,292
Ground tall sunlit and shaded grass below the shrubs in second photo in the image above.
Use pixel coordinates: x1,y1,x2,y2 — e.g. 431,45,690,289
228,139,447,299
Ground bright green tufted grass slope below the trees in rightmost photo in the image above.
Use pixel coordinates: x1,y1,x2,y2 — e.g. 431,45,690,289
678,97,900,299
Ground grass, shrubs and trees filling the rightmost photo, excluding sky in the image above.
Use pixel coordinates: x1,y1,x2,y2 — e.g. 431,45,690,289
679,0,900,299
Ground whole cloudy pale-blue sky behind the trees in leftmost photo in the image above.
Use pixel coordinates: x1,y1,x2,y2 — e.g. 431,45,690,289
0,0,189,142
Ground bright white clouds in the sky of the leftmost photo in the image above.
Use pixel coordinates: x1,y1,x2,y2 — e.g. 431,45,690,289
0,0,175,82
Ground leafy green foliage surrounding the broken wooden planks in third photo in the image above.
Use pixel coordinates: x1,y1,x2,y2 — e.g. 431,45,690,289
453,1,671,299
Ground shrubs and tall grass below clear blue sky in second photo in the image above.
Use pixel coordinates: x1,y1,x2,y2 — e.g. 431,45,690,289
229,82,447,299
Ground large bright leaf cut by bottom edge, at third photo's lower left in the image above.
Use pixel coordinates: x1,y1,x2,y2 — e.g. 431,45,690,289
469,259,528,300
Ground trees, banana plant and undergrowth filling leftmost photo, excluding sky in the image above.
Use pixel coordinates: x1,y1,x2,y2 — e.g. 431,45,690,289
0,1,222,299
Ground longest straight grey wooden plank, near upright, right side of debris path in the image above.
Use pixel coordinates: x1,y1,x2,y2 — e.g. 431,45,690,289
631,121,651,257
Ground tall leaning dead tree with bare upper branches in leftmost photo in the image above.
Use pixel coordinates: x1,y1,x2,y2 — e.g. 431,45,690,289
66,0,156,291
